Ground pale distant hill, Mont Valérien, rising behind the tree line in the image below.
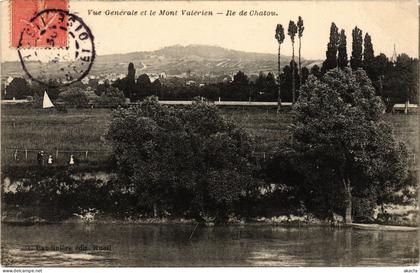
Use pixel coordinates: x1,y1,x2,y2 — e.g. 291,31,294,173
2,45,319,77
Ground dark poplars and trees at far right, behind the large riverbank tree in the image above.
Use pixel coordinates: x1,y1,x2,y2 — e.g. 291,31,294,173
321,22,418,107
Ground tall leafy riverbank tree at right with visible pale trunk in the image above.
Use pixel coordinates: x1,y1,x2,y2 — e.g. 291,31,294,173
292,69,407,223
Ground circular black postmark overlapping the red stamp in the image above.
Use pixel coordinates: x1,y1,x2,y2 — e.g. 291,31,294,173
18,9,95,87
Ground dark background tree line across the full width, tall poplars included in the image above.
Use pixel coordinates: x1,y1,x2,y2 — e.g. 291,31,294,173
2,16,418,109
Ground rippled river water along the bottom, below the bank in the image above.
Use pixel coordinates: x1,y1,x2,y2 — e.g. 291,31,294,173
1,223,419,266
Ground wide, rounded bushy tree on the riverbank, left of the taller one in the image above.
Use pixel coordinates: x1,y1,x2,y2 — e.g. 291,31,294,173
107,98,256,220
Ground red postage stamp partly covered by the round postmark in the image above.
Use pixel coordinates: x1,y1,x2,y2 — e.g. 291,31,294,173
10,0,68,48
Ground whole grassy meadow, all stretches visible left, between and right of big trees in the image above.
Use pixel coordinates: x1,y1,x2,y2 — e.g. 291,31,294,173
1,106,418,164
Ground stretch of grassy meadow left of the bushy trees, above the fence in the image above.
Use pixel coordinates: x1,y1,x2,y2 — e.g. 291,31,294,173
1,107,111,164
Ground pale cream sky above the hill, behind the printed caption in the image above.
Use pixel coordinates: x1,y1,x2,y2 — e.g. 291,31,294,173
0,0,419,61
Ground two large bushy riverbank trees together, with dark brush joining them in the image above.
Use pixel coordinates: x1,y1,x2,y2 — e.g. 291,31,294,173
107,68,413,223
